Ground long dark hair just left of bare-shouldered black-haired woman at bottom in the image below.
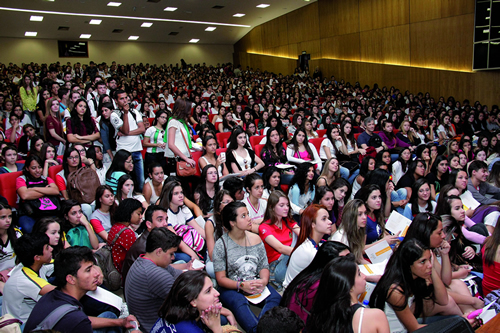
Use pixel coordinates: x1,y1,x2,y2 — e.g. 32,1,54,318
280,241,351,308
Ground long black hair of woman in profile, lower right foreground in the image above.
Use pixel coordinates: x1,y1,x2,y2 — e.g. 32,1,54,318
369,237,434,318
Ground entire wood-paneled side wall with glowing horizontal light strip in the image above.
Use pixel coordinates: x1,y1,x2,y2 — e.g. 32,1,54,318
234,0,500,105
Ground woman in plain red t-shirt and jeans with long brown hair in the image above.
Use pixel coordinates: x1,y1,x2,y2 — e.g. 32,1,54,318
259,191,300,289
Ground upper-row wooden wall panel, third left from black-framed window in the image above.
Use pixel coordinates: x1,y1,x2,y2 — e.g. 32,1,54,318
318,0,359,38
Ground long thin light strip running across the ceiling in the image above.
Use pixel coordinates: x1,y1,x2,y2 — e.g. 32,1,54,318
0,7,251,28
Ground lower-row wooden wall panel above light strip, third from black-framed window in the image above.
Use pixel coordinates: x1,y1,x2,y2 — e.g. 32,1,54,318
321,33,360,61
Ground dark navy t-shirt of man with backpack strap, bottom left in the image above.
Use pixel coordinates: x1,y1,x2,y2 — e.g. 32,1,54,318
24,289,93,333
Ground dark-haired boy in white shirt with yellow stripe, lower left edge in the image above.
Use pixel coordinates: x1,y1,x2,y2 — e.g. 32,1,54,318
2,234,55,322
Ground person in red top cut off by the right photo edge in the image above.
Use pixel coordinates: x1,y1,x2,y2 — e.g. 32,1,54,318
481,219,500,296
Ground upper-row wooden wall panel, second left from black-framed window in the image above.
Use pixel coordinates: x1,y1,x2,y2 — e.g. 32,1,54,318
359,0,410,31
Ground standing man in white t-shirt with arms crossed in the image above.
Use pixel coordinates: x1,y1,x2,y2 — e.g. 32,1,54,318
110,90,145,192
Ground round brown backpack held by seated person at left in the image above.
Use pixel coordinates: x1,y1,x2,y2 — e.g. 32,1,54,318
67,167,101,204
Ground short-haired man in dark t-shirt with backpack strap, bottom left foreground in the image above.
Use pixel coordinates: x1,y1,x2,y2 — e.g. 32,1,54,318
24,246,140,333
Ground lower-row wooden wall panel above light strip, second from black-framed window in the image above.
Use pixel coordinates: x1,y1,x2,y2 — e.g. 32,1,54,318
360,24,410,65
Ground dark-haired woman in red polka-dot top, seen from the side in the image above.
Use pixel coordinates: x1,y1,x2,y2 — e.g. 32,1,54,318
108,198,144,273
